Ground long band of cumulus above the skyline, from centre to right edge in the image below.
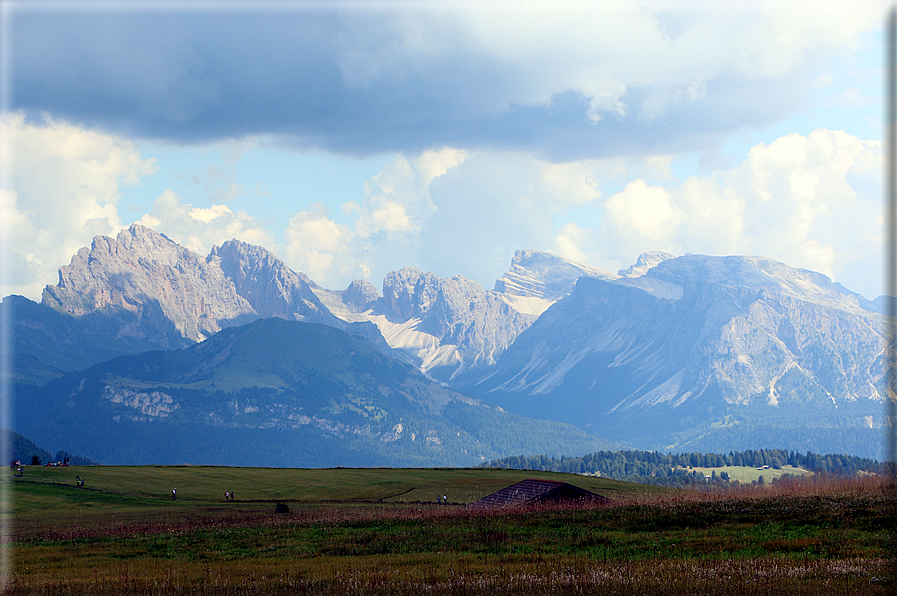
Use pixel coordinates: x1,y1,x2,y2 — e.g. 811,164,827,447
292,129,882,298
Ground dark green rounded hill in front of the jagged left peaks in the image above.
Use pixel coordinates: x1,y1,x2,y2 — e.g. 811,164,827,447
17,319,611,467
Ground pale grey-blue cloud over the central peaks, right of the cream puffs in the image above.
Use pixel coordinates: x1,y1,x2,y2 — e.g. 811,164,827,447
418,151,621,287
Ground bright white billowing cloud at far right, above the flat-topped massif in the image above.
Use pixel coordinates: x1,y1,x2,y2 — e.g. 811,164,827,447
726,129,883,286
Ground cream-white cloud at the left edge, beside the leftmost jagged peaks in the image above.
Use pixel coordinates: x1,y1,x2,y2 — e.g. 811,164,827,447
0,114,156,299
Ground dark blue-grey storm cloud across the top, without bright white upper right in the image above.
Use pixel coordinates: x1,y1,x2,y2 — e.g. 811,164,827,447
5,4,860,160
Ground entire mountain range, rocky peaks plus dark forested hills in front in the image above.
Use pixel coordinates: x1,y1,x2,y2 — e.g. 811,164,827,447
4,224,890,465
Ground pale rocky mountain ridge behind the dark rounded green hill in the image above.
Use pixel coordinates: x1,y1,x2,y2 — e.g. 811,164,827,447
10,224,892,455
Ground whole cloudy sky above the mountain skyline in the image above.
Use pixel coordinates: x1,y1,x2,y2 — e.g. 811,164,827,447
0,0,887,300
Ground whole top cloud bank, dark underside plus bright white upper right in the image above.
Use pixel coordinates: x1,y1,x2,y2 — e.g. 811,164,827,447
12,0,885,161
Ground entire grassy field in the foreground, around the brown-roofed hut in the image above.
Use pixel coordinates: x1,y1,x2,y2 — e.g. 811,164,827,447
7,467,897,596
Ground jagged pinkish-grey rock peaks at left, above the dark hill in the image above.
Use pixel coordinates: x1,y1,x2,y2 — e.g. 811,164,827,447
43,224,389,351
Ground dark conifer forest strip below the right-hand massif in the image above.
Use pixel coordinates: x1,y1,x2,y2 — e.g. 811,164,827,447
480,449,883,485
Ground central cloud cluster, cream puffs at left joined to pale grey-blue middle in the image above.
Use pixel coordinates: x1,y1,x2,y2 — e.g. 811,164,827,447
283,148,608,287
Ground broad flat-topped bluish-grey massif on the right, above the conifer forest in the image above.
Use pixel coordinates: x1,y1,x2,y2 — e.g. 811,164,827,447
468,250,884,448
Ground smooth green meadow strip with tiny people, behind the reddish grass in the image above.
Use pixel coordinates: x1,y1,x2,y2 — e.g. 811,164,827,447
5,466,670,536
